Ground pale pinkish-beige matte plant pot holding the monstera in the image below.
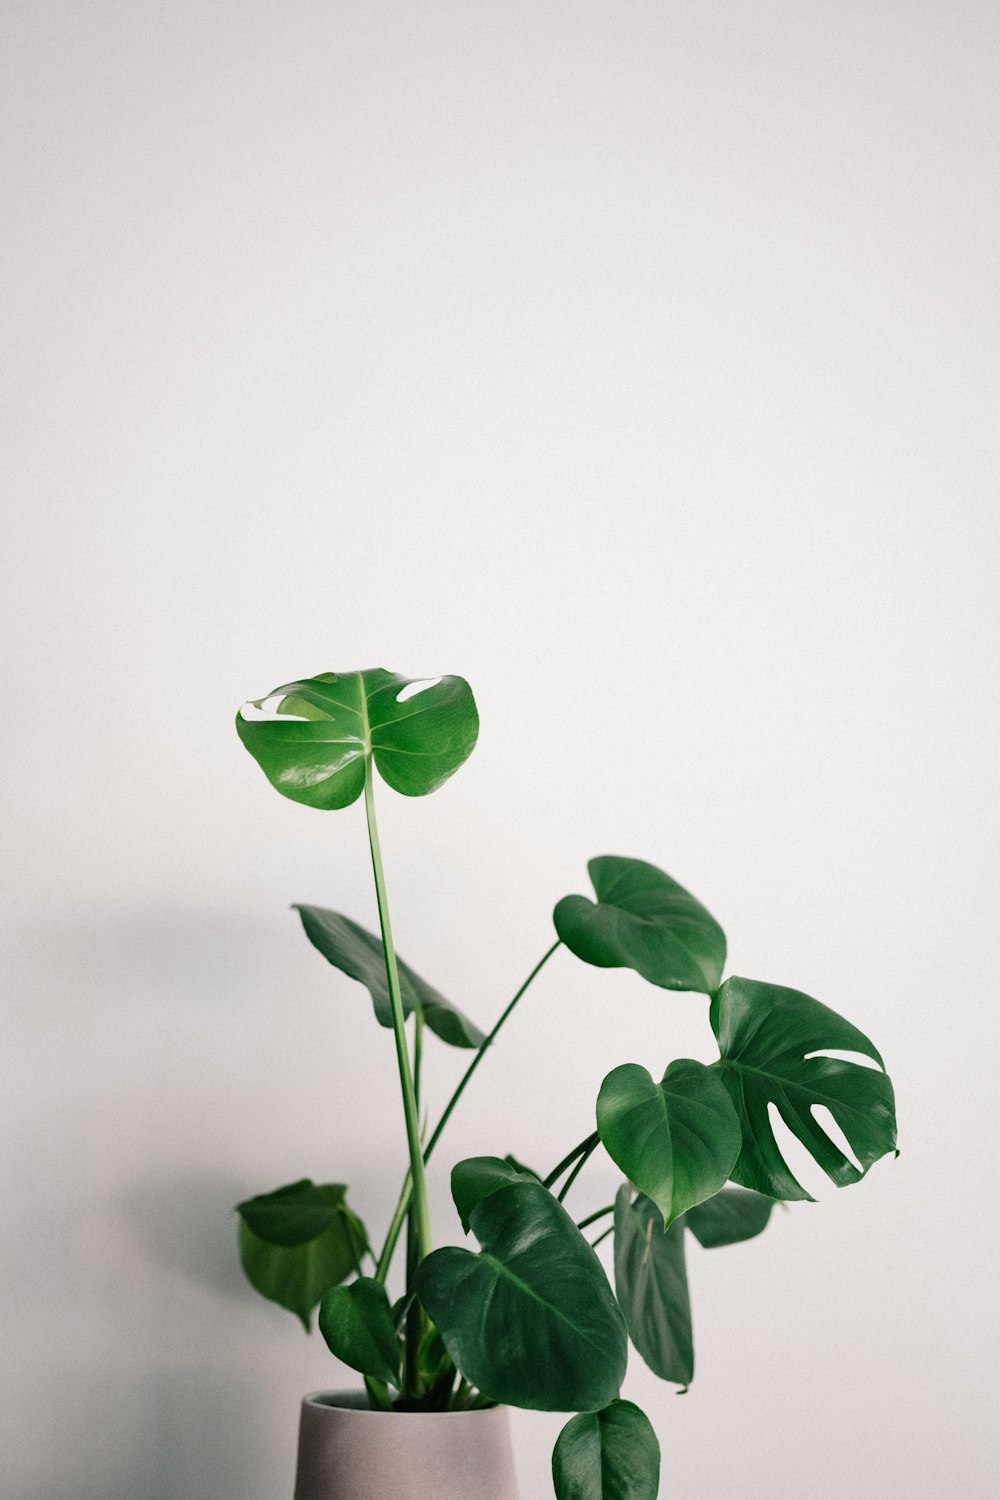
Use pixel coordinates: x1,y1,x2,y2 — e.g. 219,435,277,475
295,1391,517,1500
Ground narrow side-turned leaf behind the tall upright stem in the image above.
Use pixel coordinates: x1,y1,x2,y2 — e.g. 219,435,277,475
295,906,486,1047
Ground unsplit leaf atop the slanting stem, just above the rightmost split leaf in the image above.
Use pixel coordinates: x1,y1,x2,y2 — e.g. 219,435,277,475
553,855,726,995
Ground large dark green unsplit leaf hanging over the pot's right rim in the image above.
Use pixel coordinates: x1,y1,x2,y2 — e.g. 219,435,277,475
415,1181,628,1412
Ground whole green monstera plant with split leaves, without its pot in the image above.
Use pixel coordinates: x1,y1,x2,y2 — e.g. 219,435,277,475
237,669,895,1500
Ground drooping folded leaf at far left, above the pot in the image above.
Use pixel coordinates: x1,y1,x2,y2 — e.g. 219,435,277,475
238,1178,367,1332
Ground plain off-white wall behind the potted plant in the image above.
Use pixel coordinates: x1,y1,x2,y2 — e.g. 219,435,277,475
0,0,1000,1500
